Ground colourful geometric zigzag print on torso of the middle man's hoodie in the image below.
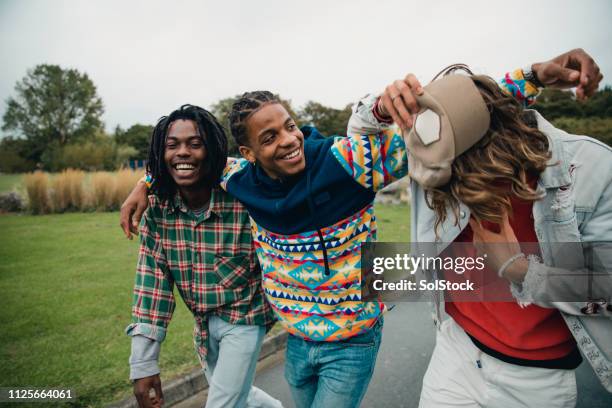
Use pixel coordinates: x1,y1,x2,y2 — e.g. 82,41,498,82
251,205,384,341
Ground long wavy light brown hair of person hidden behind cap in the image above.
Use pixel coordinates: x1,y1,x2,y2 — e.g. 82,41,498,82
425,75,551,236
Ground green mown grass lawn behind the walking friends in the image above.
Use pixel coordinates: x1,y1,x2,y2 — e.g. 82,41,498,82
0,206,409,406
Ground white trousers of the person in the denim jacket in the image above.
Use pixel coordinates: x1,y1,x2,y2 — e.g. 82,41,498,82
419,319,576,408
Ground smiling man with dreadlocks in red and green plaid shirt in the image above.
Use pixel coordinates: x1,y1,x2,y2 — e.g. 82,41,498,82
126,105,282,408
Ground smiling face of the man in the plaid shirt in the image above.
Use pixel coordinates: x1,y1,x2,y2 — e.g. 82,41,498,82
164,119,206,190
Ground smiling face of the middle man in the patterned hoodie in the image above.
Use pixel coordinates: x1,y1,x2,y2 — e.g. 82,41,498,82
240,103,306,179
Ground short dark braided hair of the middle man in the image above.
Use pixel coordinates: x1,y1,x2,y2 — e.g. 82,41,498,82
229,91,281,146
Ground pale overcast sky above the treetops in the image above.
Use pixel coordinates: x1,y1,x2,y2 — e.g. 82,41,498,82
0,0,612,130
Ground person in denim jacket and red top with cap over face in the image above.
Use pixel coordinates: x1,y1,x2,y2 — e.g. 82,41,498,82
351,59,612,408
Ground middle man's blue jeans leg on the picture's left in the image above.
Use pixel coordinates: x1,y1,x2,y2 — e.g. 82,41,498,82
285,334,319,408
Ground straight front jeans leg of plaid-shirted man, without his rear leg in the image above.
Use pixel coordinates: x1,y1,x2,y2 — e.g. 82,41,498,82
206,316,265,408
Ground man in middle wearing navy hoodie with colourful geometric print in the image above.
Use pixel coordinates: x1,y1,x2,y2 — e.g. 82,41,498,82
122,49,604,408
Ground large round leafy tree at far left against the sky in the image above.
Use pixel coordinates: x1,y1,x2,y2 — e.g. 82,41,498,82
2,64,104,162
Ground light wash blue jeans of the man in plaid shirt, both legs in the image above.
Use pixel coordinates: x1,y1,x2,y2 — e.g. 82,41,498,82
204,316,282,408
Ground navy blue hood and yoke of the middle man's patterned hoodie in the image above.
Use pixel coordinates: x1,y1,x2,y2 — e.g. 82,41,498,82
227,126,375,235
